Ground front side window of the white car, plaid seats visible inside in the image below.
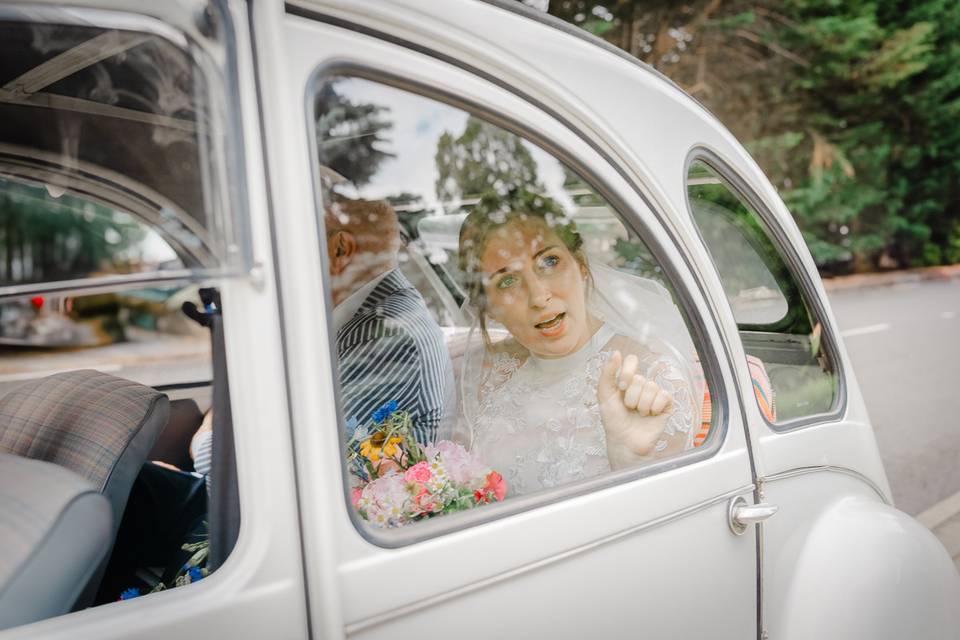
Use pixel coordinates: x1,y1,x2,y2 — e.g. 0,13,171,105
0,3,249,628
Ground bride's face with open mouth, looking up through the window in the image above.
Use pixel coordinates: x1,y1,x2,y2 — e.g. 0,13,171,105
480,221,591,358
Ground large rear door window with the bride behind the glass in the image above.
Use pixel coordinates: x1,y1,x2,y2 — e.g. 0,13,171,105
312,76,711,529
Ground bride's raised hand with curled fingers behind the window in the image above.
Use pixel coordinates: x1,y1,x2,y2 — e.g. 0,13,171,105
597,351,673,469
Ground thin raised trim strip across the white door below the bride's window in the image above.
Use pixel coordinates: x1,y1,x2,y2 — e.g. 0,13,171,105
344,484,756,636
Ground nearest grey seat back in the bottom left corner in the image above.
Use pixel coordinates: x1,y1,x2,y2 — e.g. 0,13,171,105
0,454,114,629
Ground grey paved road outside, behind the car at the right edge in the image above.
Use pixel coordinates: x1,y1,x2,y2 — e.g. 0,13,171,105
830,279,960,514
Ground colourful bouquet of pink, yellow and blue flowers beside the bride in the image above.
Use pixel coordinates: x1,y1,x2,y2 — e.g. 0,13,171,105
347,400,507,528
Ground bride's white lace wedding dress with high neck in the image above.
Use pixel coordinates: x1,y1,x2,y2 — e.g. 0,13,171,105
471,324,699,495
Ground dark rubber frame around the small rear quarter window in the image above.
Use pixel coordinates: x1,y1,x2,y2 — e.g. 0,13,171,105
683,145,848,433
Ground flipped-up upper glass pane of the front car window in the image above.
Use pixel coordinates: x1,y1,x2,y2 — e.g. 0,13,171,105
0,16,248,293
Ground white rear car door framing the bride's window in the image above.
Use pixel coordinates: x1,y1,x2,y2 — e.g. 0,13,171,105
253,2,757,638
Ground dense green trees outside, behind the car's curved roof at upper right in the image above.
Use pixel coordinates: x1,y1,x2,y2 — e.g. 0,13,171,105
536,0,960,270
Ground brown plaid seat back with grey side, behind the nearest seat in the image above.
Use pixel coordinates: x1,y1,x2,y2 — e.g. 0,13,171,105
0,369,169,523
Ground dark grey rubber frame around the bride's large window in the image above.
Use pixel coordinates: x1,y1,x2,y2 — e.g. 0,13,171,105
303,62,736,549
